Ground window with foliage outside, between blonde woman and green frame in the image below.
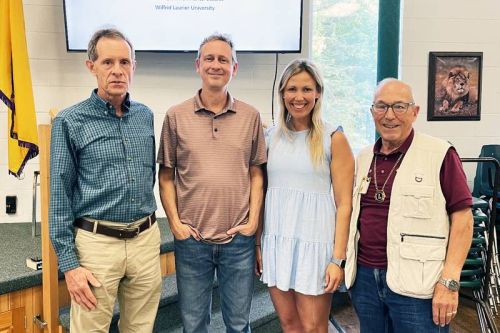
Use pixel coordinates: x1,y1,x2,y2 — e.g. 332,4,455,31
311,0,379,153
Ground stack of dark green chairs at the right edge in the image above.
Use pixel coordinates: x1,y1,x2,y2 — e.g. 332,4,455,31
460,145,500,333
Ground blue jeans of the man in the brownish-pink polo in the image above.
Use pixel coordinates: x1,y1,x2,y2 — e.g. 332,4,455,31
174,234,255,333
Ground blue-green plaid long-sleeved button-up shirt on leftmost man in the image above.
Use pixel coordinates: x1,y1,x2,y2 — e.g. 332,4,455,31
49,90,156,272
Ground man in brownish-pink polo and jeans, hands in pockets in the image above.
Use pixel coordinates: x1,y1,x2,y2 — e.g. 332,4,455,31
158,34,266,332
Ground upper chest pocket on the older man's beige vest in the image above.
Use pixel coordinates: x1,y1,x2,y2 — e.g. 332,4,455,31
401,185,434,219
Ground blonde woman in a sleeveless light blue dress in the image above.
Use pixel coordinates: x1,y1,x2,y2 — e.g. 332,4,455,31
256,60,354,332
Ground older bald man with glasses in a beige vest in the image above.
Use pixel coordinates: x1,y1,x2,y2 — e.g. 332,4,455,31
345,79,473,333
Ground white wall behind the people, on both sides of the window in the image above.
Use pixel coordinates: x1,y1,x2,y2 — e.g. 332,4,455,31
0,0,500,223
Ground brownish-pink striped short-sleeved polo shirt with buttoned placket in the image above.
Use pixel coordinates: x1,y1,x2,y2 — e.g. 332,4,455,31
157,90,267,243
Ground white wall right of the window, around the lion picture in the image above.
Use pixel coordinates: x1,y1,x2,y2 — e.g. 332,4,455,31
401,0,500,185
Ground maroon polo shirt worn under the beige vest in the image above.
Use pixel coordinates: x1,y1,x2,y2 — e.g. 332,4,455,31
358,130,472,269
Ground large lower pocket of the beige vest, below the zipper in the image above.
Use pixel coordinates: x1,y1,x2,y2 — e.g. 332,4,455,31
399,240,446,295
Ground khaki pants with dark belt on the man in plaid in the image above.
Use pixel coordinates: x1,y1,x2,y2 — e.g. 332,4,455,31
70,219,162,333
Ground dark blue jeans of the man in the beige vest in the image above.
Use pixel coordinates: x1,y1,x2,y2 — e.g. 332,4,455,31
350,265,449,333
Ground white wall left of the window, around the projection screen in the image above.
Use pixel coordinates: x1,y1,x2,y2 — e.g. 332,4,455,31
0,0,310,223
